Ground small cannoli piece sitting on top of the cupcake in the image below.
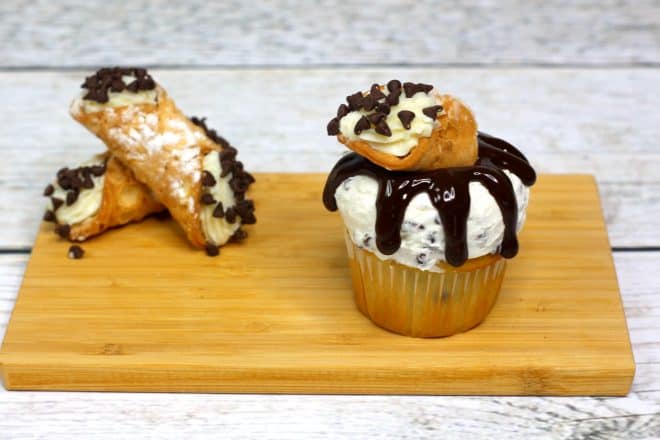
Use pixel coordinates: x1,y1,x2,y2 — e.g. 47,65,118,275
327,80,478,171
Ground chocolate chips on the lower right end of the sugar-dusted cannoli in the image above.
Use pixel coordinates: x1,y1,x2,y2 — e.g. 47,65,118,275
190,116,257,256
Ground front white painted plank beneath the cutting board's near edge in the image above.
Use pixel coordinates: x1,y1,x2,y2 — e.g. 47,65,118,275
0,252,660,439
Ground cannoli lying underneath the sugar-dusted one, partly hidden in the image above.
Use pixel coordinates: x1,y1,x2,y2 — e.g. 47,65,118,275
44,152,165,241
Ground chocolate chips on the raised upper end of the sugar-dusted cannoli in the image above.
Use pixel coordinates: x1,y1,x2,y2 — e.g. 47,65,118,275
81,67,156,104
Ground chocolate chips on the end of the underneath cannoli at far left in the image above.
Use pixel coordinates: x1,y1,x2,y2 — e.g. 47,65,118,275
44,163,105,238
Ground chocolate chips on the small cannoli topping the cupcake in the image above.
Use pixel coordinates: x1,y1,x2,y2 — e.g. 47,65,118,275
327,79,442,137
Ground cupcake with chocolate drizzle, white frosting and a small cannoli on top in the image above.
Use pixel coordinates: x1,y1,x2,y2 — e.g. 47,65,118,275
323,80,536,337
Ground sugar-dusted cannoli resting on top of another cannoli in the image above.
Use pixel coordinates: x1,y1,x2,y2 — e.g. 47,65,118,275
71,68,256,255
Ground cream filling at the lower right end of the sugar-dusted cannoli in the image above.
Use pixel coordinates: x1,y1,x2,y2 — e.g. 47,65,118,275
200,151,241,246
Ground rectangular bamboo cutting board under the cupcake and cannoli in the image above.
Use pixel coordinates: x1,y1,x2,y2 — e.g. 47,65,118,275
0,174,635,395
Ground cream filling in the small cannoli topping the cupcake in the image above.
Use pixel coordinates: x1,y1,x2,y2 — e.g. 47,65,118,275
339,90,439,157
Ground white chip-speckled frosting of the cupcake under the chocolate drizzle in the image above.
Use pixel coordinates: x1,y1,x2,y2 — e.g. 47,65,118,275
335,170,529,271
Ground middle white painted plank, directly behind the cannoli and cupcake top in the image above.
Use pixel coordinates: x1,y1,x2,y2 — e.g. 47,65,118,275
0,68,660,247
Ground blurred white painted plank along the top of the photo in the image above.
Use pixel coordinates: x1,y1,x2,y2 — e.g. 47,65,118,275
0,0,660,66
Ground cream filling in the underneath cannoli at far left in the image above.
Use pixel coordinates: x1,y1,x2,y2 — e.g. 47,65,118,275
48,155,105,225
